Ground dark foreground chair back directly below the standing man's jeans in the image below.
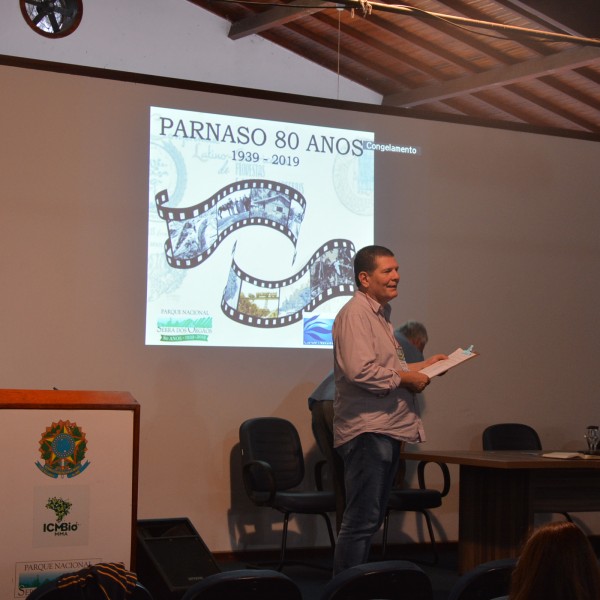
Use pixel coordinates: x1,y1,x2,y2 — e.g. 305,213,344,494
320,560,433,600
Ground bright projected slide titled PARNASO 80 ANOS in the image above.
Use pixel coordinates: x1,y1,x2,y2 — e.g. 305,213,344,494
146,107,374,348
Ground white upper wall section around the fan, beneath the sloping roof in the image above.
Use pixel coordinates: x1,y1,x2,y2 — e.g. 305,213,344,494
0,0,381,104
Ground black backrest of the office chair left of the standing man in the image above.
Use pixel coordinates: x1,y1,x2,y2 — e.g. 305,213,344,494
240,417,304,491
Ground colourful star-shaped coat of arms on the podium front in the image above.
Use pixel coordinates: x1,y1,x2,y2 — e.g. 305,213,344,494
35,421,90,479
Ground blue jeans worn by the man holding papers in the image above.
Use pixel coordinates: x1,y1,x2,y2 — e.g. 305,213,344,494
333,433,401,575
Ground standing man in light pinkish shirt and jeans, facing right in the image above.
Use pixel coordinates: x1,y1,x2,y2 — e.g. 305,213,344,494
333,246,447,575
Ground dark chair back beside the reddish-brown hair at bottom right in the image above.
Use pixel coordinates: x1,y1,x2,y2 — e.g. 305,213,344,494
448,558,517,600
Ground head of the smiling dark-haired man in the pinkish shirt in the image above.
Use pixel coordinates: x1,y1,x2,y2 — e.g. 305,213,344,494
354,246,400,304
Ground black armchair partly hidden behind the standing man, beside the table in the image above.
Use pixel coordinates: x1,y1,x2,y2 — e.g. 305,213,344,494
382,460,450,563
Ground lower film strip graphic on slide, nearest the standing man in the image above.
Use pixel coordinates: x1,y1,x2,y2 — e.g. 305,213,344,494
221,239,356,328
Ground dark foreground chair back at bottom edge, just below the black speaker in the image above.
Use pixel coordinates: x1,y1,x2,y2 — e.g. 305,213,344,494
181,569,302,600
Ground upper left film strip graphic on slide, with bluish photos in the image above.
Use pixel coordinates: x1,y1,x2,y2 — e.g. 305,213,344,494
154,179,306,269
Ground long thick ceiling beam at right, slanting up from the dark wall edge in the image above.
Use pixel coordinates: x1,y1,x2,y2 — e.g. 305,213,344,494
382,46,600,108
